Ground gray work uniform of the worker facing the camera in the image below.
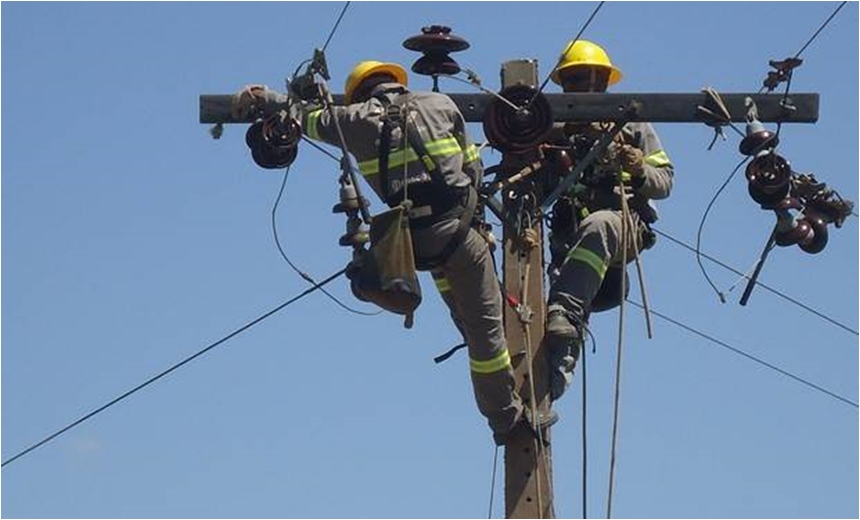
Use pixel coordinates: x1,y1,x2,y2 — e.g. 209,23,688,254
547,123,674,338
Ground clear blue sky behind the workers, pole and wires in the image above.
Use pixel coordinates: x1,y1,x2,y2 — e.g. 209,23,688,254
0,2,858,518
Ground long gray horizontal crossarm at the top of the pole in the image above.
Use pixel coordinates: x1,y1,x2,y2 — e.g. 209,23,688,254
200,93,818,124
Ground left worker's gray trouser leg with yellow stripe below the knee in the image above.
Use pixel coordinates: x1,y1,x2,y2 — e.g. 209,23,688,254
433,230,522,433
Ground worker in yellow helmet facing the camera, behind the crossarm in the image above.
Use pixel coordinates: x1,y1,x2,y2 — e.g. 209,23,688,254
545,40,674,400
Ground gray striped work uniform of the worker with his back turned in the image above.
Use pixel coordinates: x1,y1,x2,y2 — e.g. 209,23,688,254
302,83,522,433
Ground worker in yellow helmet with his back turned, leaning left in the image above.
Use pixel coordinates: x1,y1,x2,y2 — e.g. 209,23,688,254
235,61,557,445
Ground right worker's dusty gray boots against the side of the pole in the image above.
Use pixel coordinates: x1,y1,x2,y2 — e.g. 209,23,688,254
545,309,581,401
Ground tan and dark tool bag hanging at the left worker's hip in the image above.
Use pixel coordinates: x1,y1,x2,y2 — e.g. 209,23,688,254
346,205,421,329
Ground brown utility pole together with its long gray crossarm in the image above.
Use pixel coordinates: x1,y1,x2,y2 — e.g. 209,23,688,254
200,72,818,518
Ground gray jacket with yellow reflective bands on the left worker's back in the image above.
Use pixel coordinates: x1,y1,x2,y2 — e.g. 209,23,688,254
303,83,483,207
